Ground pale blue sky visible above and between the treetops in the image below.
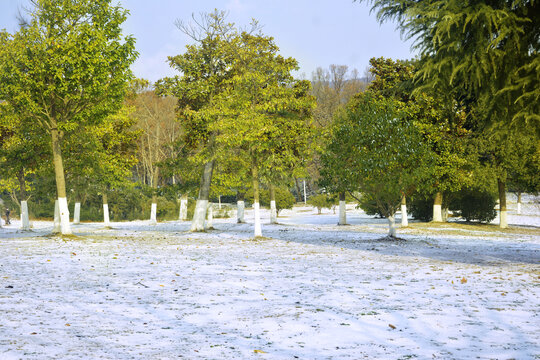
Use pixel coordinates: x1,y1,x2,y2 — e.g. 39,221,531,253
0,0,413,81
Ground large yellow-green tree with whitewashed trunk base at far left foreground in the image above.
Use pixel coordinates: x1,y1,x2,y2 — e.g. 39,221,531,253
0,0,137,234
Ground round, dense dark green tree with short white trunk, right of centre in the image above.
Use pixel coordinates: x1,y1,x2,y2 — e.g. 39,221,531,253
321,92,431,238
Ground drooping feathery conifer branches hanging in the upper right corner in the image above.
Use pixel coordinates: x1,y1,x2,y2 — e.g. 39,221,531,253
358,0,540,131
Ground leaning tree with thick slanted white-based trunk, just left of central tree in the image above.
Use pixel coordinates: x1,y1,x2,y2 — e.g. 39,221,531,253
156,10,240,231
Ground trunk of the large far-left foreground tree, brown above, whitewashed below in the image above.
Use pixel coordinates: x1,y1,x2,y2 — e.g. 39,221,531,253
51,128,71,235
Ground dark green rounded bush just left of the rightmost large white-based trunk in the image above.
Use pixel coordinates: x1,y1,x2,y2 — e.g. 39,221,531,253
449,189,497,223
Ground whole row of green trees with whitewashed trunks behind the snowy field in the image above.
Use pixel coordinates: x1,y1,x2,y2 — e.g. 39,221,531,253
0,0,540,236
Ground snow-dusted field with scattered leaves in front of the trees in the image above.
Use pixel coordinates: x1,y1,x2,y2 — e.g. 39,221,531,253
0,200,540,360
